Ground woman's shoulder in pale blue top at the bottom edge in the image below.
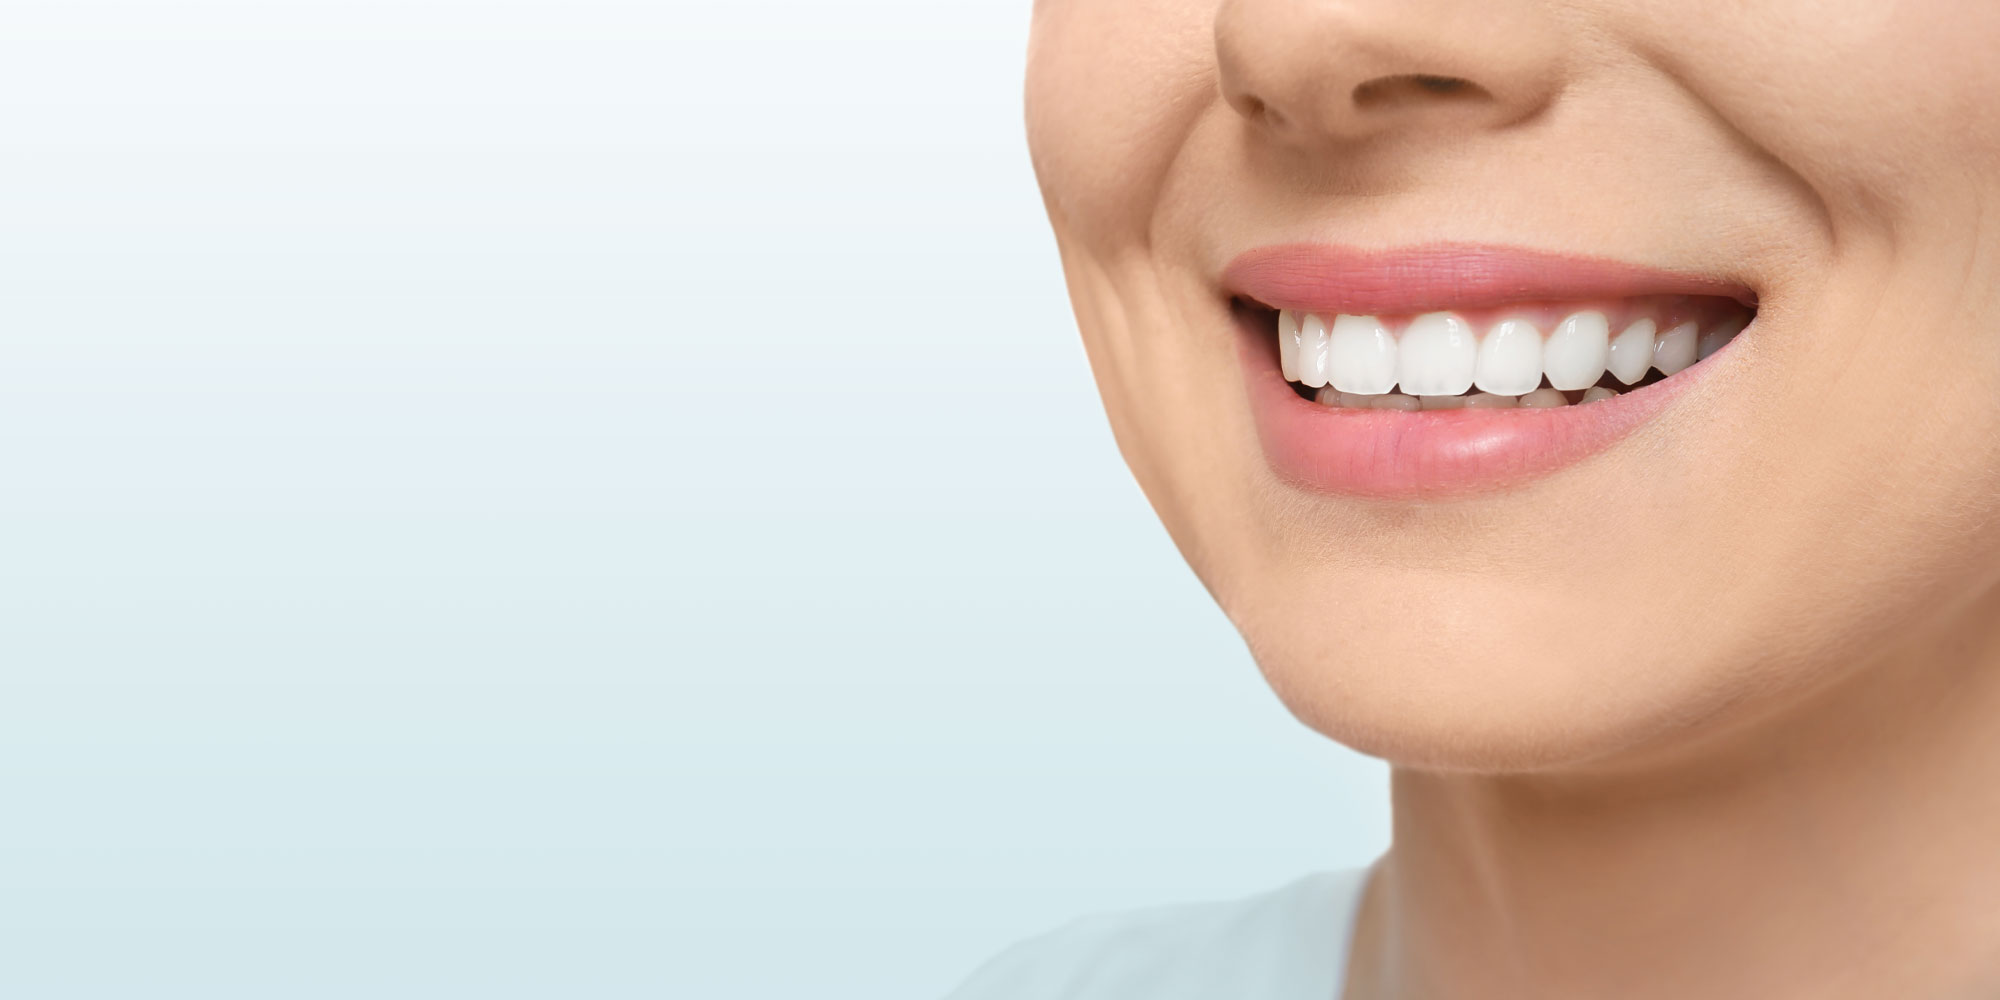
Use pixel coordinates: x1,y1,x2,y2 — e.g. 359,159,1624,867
946,868,1368,1000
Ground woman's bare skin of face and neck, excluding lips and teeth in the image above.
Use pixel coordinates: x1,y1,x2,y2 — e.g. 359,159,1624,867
1028,0,2000,1000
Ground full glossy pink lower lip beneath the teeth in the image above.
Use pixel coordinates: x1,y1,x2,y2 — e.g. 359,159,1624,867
1238,318,1728,500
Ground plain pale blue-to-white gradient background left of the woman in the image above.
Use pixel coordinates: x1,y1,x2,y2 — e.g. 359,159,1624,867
0,0,1388,1000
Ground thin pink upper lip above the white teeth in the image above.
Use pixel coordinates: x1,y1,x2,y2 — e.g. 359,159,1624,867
1222,244,1756,316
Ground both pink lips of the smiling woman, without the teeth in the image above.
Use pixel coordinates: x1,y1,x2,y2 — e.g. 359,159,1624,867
1224,244,1756,500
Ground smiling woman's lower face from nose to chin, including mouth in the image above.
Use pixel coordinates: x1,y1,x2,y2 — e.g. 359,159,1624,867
1028,0,2000,770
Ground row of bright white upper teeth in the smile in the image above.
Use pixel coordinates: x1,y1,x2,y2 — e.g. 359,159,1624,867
1278,310,1746,396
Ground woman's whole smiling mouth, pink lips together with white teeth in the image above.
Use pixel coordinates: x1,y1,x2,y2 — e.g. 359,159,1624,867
1218,244,1758,500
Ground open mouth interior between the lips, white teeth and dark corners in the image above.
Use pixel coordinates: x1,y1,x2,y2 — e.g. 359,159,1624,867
1236,294,1756,410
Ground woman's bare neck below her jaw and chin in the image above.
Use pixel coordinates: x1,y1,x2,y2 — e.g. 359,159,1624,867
1348,584,2000,1000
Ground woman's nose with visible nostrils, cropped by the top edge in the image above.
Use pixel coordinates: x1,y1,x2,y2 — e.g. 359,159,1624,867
1216,0,1562,146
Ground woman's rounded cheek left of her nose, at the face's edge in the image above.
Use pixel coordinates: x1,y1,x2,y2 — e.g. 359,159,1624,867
1026,0,1218,248
